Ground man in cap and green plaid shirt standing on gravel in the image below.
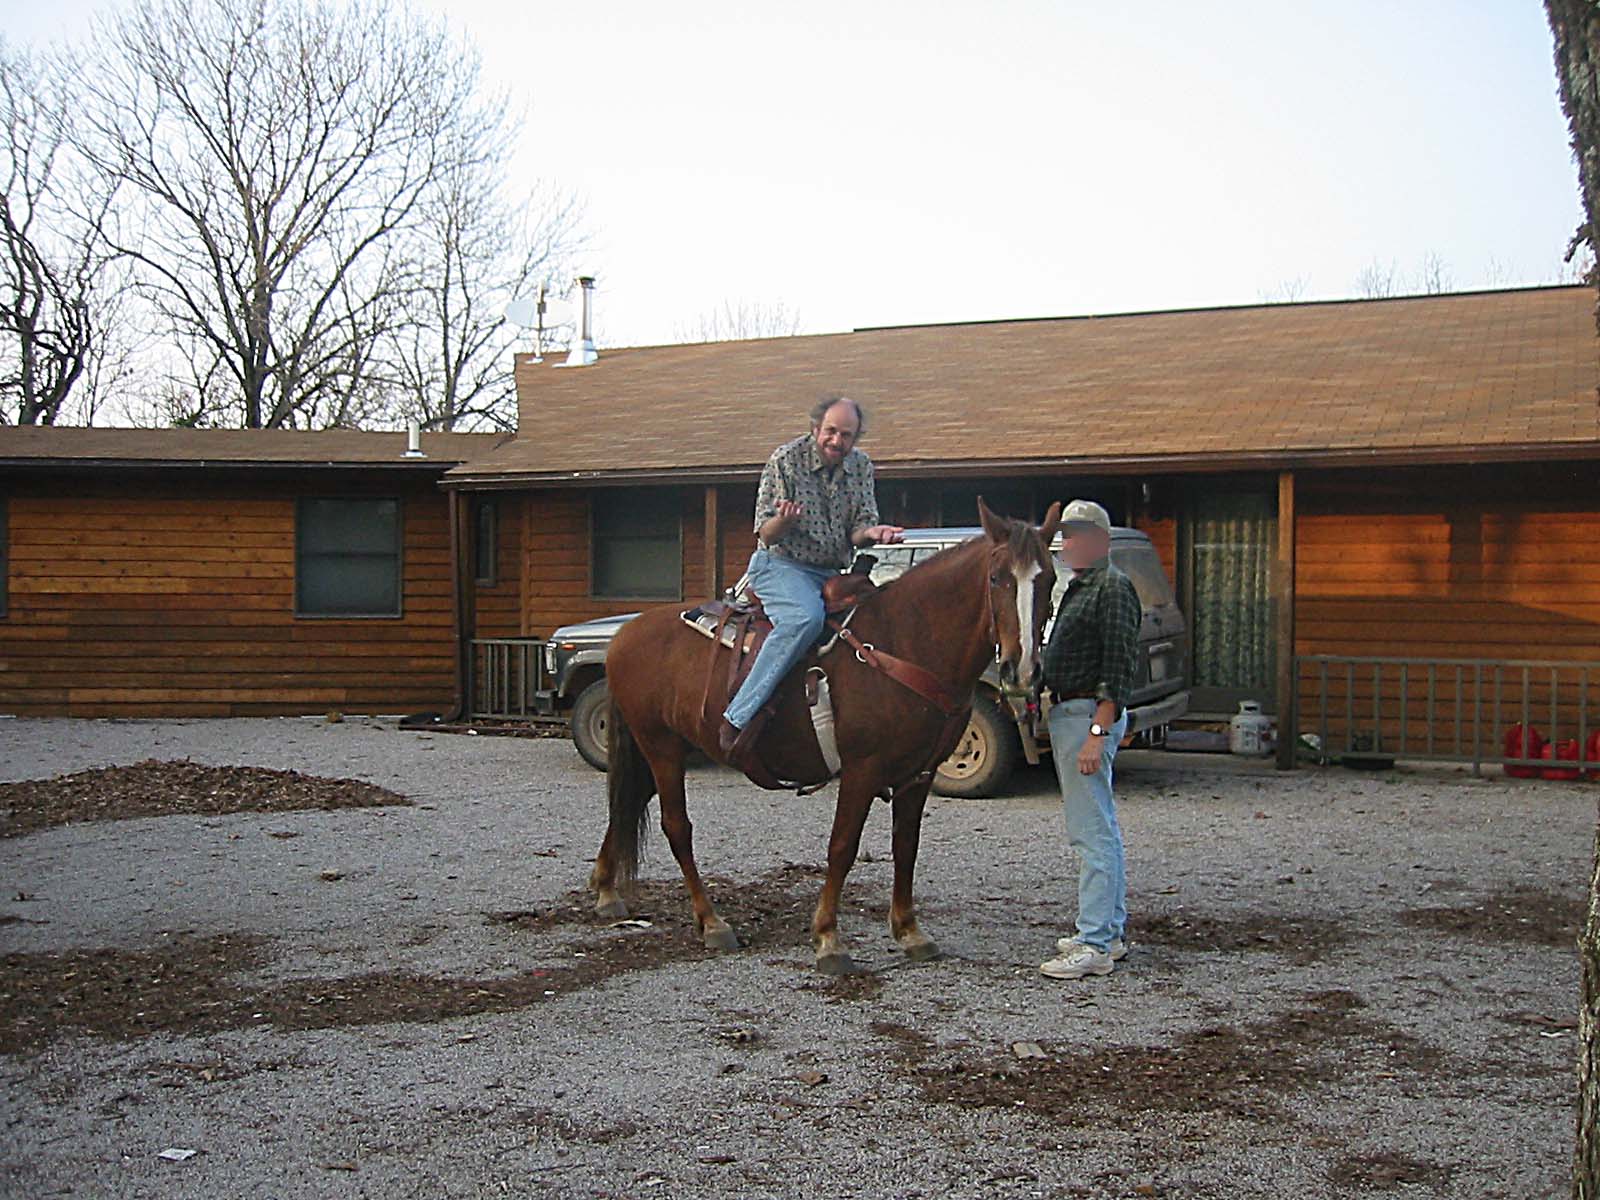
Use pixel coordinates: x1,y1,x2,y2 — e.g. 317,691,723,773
1038,499,1142,979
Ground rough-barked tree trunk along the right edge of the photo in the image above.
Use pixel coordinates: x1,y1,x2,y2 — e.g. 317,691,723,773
1544,0,1600,1200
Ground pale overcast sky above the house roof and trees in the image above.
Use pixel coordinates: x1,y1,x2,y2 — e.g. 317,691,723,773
12,0,1579,344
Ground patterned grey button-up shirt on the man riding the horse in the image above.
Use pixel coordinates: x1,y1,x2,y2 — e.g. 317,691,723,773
755,434,878,568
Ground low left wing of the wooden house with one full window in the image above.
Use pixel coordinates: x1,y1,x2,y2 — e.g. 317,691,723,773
0,426,518,717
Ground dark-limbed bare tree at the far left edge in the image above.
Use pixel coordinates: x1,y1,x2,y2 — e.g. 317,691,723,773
0,43,109,426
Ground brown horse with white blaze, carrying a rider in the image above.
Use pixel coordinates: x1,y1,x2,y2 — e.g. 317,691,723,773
589,499,1061,974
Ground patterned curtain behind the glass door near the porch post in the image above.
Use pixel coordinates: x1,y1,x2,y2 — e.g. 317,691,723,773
1189,493,1278,688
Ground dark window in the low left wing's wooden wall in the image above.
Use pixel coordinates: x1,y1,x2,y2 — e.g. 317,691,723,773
294,498,400,616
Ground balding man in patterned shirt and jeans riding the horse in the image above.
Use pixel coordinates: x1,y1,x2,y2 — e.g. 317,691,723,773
717,397,904,768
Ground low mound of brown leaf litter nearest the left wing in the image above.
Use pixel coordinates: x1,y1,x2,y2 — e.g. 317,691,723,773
0,758,411,837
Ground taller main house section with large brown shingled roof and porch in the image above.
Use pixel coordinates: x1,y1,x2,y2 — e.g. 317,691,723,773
445,286,1600,757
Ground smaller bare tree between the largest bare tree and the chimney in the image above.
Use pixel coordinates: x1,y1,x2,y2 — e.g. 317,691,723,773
382,167,582,429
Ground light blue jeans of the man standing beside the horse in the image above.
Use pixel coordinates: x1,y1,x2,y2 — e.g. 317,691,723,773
1050,699,1128,950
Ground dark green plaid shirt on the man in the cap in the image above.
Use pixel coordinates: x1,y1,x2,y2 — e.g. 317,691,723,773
1043,562,1144,715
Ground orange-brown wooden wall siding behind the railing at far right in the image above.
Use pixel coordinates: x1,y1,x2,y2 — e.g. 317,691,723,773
1294,466,1600,752
